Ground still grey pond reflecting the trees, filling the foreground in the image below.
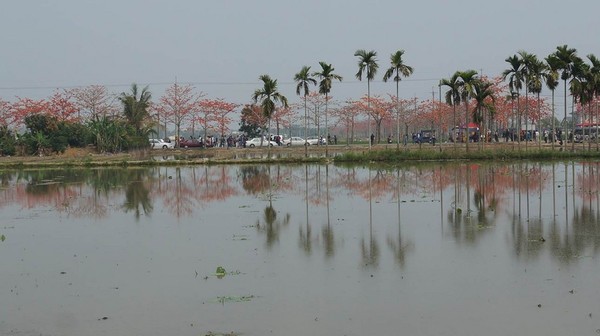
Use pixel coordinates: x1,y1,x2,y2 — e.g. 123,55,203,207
0,162,600,336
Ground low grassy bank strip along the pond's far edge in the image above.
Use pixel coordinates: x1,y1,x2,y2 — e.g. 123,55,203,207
0,142,600,168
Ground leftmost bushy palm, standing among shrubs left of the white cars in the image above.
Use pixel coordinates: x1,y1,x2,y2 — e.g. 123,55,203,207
119,83,152,136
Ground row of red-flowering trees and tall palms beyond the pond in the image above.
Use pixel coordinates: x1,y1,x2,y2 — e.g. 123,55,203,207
0,45,600,155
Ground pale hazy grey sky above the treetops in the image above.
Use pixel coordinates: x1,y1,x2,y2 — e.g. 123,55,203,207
0,0,600,103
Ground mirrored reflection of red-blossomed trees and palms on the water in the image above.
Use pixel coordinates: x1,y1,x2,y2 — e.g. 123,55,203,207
0,162,600,268
